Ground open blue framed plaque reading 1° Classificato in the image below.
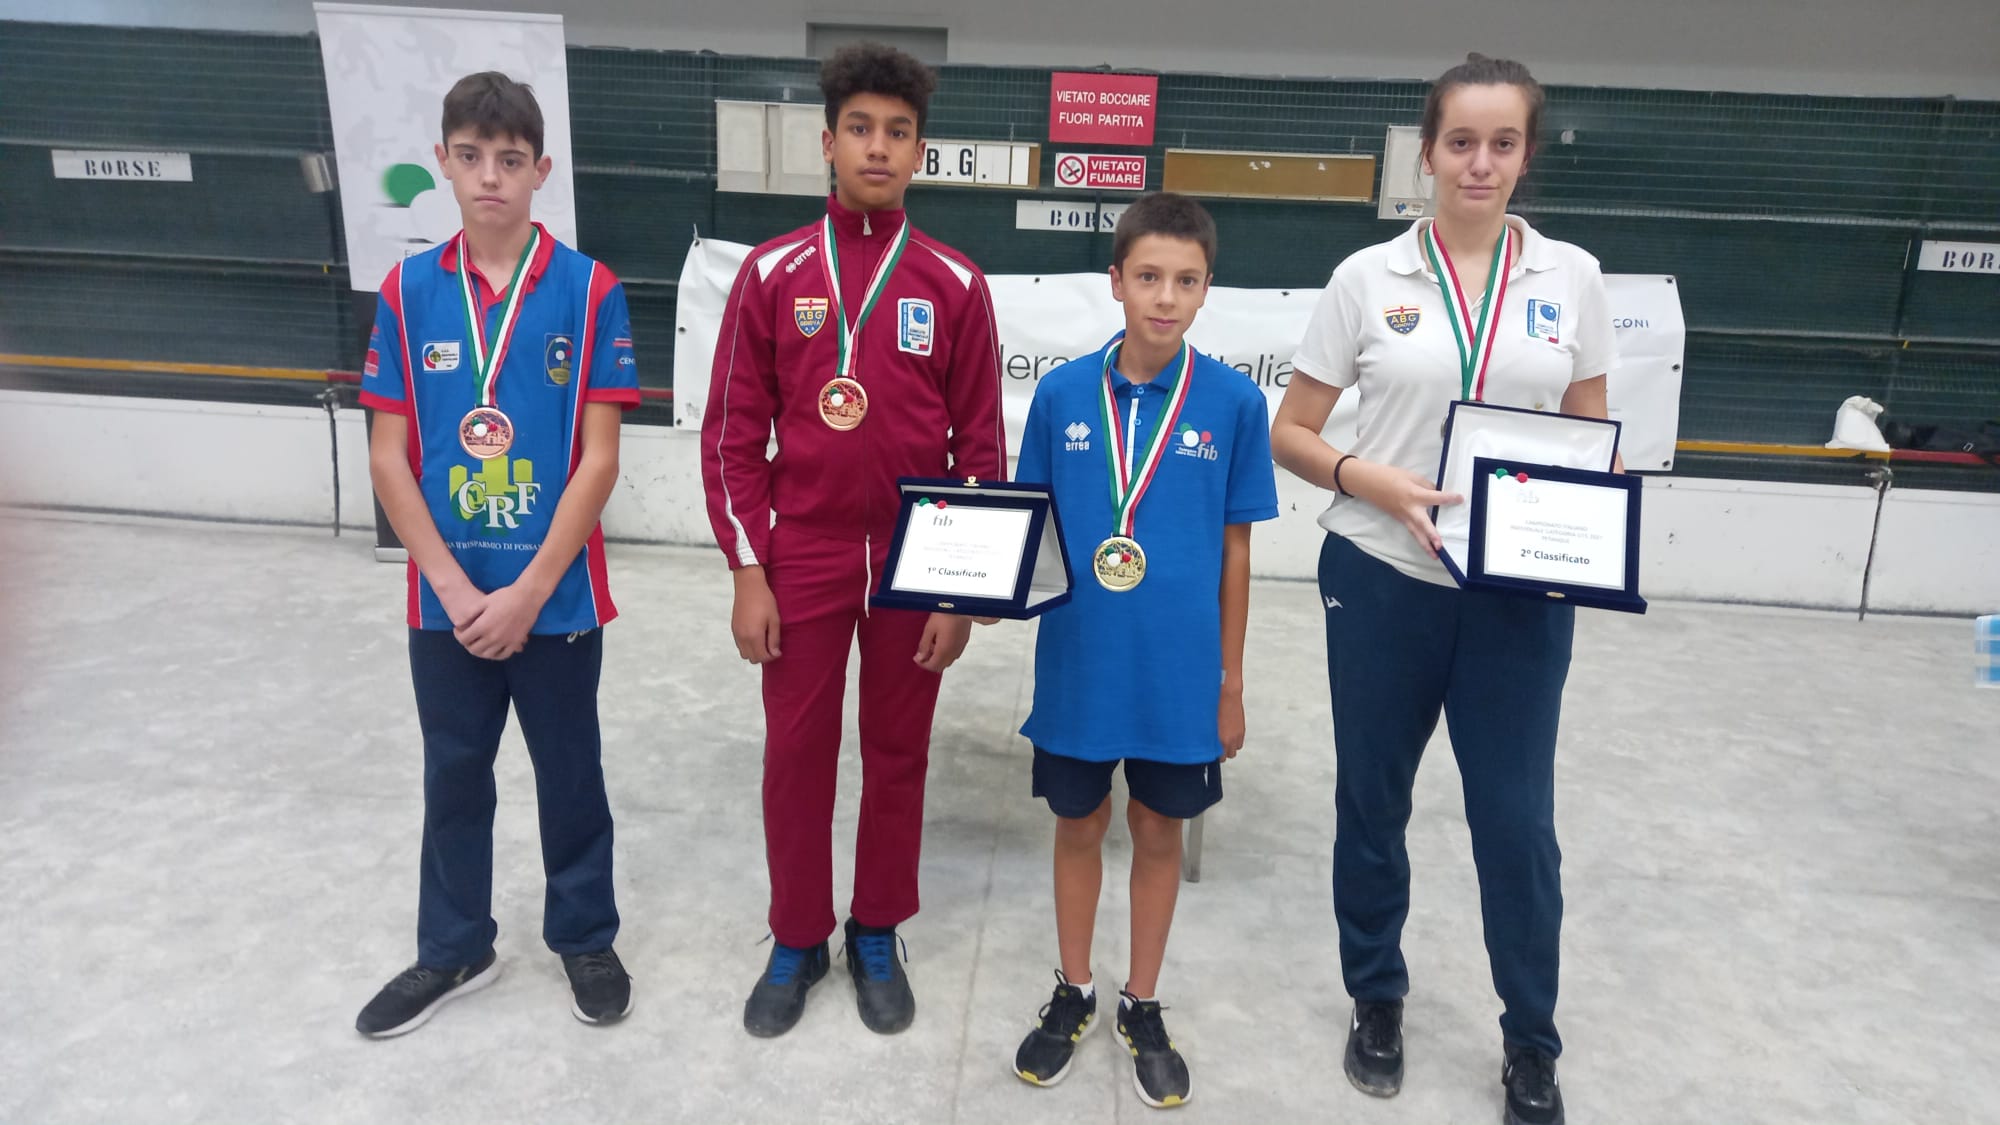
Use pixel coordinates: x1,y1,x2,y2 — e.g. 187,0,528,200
868,476,1070,619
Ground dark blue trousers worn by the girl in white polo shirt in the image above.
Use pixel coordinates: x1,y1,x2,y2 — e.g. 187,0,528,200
1320,534,1576,1055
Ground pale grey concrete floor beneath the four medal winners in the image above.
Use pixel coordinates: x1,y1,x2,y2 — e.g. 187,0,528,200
0,510,2000,1125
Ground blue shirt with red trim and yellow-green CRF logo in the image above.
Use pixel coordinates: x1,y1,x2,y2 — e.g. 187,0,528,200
362,230,638,633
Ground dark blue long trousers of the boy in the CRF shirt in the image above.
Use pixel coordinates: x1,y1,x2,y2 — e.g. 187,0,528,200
410,629,618,969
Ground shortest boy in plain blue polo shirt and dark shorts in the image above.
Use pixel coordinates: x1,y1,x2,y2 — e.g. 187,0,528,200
1014,192,1278,1109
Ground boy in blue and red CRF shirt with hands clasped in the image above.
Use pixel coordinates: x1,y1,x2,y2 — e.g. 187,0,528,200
354,72,638,1039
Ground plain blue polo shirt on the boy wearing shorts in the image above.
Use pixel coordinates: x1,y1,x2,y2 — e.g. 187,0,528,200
1014,332,1278,763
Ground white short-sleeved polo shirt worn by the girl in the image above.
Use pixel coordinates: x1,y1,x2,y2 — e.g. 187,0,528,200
1292,214,1618,587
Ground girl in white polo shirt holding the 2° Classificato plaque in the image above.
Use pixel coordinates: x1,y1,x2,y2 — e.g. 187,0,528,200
1270,54,1614,1125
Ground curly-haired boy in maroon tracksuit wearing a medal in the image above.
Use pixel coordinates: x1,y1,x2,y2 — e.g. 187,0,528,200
702,44,1006,1037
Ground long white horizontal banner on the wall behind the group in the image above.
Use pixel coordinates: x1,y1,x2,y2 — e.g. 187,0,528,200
676,238,1686,464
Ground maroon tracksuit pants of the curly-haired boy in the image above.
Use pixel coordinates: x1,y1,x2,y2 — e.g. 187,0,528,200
764,520,940,947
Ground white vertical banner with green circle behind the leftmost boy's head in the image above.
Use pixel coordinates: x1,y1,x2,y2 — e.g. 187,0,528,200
312,4,576,292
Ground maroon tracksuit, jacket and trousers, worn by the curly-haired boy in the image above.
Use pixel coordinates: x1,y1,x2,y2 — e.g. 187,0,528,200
702,198,1006,947
